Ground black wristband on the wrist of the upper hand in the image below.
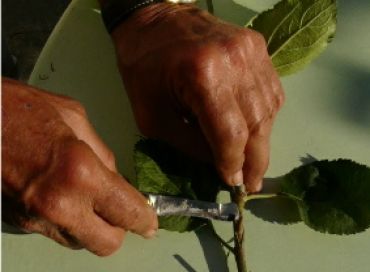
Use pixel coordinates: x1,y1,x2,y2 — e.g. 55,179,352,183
101,0,165,33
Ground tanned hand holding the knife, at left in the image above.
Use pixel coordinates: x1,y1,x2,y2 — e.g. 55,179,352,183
2,79,157,256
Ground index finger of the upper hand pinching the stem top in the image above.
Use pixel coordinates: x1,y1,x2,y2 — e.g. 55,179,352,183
193,86,248,186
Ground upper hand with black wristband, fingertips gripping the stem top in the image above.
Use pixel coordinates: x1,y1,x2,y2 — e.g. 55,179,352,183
112,3,284,192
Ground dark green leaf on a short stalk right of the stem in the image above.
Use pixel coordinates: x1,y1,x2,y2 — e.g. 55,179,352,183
281,159,370,234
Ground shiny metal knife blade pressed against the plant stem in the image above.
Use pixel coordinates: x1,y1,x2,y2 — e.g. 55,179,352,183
144,193,239,221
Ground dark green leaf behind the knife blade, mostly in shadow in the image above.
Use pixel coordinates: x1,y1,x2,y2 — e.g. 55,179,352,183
133,139,221,232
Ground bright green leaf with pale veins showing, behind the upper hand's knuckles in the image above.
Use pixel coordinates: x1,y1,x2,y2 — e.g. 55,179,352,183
250,0,337,76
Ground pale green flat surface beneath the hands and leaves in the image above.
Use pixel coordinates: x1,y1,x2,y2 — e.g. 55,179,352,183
2,0,370,272
